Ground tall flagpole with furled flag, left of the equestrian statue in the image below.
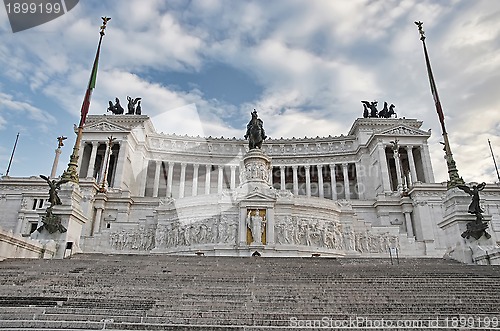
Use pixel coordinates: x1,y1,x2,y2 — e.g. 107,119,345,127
62,17,111,184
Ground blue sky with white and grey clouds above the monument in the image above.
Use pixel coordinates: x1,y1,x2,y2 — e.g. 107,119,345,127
0,0,500,182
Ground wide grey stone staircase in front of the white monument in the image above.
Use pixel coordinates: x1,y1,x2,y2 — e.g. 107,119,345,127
0,254,500,331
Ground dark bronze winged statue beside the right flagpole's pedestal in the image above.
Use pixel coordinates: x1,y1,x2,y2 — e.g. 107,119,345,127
457,182,491,240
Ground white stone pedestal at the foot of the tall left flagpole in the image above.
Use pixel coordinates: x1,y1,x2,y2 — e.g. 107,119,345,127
32,182,87,259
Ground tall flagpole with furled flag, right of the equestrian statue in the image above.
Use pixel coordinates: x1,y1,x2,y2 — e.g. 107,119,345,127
415,22,464,189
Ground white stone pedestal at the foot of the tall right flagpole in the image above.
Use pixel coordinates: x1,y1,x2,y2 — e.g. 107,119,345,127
438,188,500,264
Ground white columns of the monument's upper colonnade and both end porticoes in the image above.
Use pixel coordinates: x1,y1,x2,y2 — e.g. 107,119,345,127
80,141,434,200
